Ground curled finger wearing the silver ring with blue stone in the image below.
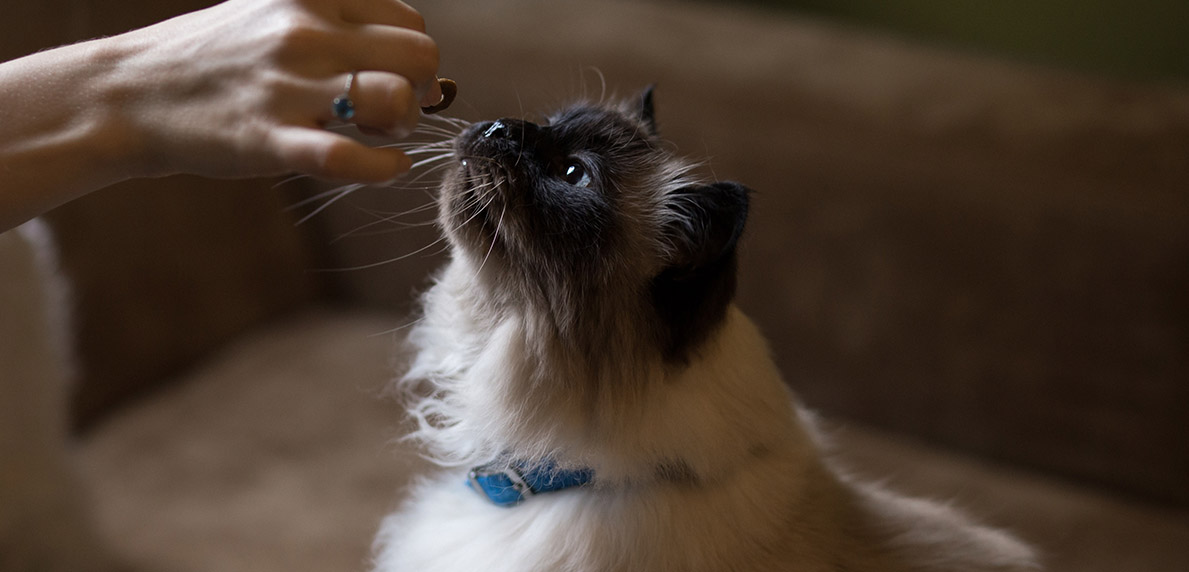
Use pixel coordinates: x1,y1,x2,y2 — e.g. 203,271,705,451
319,71,421,137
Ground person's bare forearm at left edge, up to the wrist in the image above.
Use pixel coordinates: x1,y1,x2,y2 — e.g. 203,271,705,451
0,40,143,231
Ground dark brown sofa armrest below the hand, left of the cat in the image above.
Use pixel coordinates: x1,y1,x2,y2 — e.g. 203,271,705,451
46,177,315,425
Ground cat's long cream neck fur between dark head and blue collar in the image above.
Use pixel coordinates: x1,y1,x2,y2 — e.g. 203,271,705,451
405,256,813,485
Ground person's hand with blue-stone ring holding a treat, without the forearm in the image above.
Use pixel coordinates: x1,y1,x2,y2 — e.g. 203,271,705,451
96,0,441,182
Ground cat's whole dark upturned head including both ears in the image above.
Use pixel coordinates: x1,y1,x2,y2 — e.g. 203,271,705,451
441,92,747,359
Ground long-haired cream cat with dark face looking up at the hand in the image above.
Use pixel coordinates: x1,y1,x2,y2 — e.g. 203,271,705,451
375,90,1036,572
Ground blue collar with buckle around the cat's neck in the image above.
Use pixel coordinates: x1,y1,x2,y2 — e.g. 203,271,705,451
467,460,595,507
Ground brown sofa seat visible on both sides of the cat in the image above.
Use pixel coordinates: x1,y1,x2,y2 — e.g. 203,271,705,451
82,314,1189,572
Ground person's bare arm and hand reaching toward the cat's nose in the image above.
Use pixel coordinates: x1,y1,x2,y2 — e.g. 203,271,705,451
0,0,440,234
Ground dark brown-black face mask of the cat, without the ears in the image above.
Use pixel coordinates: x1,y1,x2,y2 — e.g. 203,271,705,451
454,107,655,273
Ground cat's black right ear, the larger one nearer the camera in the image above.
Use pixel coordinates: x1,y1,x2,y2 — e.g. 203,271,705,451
652,182,750,363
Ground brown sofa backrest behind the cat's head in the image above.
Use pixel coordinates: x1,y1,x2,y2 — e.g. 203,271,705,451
304,0,1189,504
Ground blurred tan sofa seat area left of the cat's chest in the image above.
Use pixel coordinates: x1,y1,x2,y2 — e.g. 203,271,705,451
82,315,423,572
